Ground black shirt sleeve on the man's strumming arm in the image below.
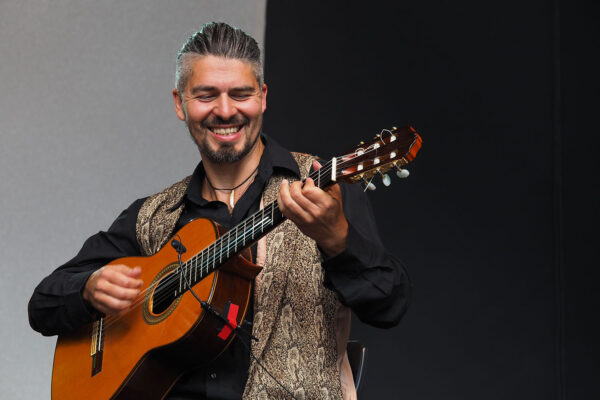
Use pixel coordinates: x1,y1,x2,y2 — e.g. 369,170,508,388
28,199,145,336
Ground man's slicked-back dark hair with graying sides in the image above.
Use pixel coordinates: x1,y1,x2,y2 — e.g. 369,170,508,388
175,22,263,95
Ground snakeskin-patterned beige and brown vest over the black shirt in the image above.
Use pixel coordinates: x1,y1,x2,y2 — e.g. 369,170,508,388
136,153,342,400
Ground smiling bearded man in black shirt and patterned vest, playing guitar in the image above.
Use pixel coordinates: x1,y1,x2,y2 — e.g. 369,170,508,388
29,23,410,399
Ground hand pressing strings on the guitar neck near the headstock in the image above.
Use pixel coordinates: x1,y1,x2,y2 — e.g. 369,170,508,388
277,161,348,257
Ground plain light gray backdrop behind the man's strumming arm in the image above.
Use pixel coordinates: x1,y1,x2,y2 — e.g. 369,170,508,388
0,0,266,399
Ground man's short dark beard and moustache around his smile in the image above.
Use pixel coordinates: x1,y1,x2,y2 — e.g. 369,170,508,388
188,116,262,164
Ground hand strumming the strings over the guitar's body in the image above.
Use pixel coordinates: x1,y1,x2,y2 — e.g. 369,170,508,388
83,264,142,314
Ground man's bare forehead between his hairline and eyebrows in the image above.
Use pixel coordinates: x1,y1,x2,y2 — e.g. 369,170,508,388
186,55,258,90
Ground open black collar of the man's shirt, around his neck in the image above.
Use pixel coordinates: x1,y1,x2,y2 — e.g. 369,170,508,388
177,133,300,209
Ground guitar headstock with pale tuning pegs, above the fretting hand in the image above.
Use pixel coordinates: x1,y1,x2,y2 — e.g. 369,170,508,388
335,126,422,186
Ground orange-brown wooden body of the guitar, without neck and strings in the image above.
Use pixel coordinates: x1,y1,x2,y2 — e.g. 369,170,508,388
52,219,261,400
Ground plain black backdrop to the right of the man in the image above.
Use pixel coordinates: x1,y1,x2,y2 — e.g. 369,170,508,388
265,0,600,399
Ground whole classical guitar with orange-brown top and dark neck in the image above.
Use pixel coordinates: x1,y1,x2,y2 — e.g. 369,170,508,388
52,127,421,400
